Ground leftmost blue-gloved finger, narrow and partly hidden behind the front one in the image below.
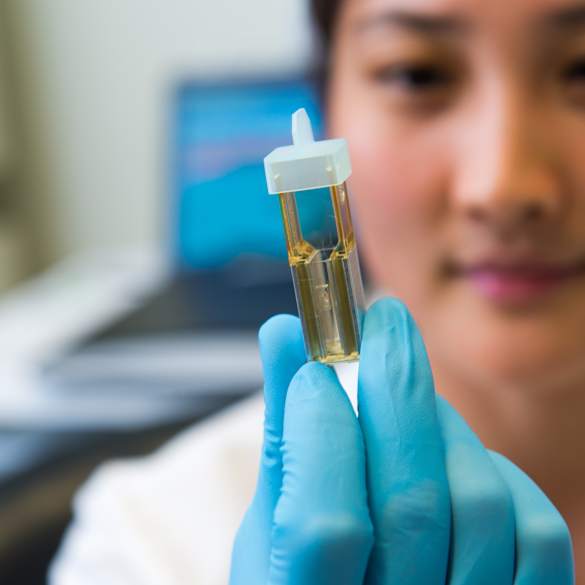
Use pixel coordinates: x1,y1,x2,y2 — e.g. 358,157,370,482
230,315,306,585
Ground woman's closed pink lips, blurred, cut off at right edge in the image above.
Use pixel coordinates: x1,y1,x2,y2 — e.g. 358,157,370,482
448,259,585,304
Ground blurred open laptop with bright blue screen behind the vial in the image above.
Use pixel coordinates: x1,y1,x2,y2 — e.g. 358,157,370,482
43,77,324,400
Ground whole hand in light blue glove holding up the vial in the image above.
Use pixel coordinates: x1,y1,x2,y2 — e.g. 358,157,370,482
230,299,573,585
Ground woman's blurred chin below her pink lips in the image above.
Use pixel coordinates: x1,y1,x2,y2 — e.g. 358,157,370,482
419,286,585,392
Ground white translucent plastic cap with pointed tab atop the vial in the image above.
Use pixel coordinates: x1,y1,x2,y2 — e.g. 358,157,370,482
264,109,351,193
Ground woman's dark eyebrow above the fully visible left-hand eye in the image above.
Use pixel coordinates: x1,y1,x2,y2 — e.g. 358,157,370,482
356,10,469,35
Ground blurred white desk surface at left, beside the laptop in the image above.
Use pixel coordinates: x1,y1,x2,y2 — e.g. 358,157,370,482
0,250,168,430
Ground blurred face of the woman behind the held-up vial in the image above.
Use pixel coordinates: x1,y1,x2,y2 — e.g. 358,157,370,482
328,0,585,389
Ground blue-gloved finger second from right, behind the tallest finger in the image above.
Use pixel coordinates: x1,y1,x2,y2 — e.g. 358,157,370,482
437,396,515,585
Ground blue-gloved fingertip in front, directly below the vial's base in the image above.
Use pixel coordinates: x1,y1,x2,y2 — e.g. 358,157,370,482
269,362,372,585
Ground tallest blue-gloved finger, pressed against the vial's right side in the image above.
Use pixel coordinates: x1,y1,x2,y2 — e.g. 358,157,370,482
358,299,450,585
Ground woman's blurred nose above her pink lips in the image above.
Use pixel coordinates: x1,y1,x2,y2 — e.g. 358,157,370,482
454,91,565,237
